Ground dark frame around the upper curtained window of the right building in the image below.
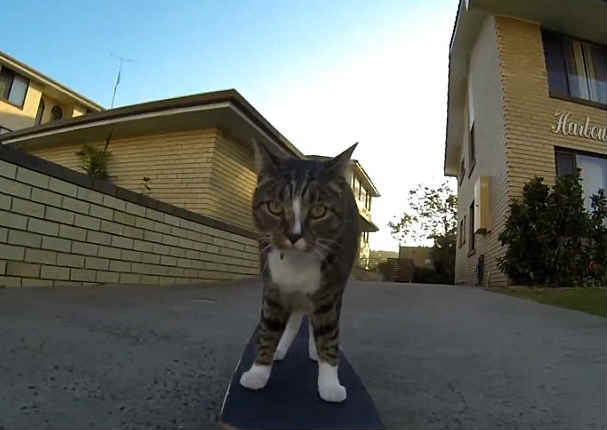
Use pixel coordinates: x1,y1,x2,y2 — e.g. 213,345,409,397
541,28,607,110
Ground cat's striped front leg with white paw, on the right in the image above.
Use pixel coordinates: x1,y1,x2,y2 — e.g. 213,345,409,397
311,306,347,402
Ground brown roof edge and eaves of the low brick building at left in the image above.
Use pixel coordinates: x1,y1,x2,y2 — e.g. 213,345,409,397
0,89,303,158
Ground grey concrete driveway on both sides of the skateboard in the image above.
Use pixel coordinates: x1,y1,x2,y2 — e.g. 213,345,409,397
0,282,607,429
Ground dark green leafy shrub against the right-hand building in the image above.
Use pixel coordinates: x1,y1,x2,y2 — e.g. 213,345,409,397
498,172,607,286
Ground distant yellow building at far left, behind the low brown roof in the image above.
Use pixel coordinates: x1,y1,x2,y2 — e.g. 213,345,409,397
0,52,103,134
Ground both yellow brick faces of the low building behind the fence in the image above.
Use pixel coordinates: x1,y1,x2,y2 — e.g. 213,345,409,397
27,128,257,230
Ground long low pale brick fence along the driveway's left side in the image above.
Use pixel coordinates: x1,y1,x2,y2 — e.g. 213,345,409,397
0,146,259,287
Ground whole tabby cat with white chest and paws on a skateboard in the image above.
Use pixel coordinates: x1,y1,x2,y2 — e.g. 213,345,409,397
240,142,360,402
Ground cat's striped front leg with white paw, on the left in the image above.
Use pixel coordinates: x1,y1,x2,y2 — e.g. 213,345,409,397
240,297,289,390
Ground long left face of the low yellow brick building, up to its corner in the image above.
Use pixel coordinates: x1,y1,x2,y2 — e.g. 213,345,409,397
27,129,220,217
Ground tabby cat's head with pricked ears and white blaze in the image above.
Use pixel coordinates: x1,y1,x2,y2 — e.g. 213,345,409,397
253,141,355,255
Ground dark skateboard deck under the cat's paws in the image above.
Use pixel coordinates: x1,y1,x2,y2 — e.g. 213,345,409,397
221,319,384,430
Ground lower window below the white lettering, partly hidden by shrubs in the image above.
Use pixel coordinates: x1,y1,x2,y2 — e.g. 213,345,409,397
555,149,607,210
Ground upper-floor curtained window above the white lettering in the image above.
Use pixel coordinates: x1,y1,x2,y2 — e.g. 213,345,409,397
542,31,607,105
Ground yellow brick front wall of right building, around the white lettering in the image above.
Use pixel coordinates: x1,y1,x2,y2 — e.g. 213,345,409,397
496,17,607,198
